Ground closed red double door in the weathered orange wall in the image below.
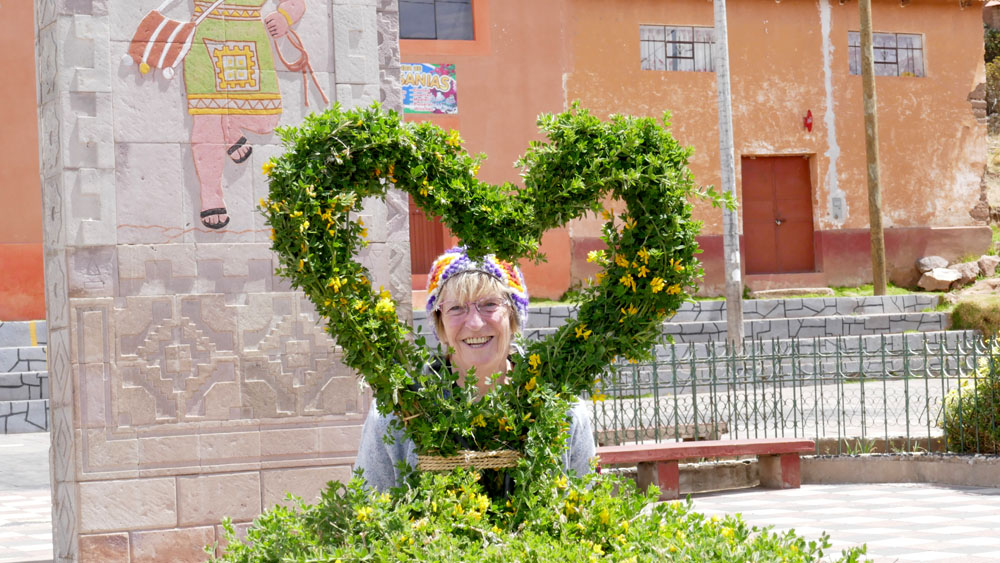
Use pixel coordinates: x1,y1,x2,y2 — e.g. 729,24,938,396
742,156,816,274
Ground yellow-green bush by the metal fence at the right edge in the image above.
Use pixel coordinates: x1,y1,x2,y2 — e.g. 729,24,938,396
938,342,1000,454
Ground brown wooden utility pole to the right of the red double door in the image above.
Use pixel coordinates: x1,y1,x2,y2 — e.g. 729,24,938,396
858,0,886,295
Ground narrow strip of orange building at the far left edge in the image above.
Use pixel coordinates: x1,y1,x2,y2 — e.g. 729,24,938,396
0,2,45,321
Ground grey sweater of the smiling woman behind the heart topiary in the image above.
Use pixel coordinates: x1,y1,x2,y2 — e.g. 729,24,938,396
354,401,596,491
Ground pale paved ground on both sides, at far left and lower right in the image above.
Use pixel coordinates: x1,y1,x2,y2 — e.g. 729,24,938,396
0,433,1000,563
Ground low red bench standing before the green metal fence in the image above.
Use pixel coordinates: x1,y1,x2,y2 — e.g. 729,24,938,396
597,438,816,500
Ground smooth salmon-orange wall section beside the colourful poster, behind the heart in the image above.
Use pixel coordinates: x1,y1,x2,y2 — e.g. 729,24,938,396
400,0,572,298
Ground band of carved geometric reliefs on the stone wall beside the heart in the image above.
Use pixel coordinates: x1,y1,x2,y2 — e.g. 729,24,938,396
103,293,367,431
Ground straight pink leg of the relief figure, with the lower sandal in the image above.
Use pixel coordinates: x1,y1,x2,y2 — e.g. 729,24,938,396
191,114,230,229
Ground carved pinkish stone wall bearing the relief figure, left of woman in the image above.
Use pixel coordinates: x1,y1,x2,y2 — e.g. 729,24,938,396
35,0,410,562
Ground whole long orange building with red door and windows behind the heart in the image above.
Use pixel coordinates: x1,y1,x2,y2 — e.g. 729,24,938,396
400,0,990,296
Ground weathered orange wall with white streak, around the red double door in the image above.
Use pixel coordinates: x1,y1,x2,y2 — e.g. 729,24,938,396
566,0,989,292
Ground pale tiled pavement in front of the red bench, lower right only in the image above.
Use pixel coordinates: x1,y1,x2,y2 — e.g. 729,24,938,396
693,483,1000,563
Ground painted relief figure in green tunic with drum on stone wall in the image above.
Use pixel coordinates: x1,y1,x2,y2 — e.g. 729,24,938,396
128,0,329,230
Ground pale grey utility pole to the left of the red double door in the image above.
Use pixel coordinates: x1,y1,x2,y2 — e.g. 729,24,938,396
714,0,744,354
